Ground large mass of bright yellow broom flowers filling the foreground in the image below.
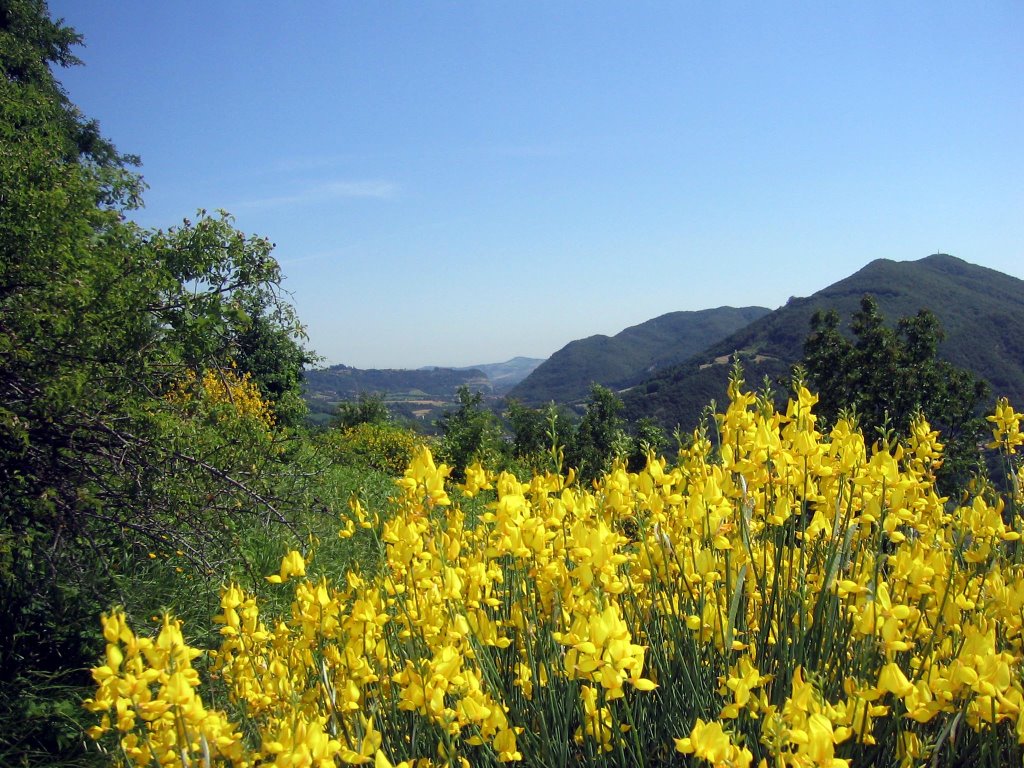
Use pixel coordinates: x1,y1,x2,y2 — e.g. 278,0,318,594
87,381,1024,768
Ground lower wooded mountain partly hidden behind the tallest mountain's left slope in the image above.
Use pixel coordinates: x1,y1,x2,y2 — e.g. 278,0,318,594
508,306,770,404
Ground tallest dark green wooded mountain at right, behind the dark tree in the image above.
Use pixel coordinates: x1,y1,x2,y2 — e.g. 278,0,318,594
624,254,1024,429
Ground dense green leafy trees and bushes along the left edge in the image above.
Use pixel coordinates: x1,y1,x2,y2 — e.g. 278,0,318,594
0,0,307,762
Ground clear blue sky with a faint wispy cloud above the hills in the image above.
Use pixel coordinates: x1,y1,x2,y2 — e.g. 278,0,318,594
50,0,1024,368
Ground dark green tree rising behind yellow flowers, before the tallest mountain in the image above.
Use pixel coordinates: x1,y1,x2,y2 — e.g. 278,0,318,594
803,296,988,488
